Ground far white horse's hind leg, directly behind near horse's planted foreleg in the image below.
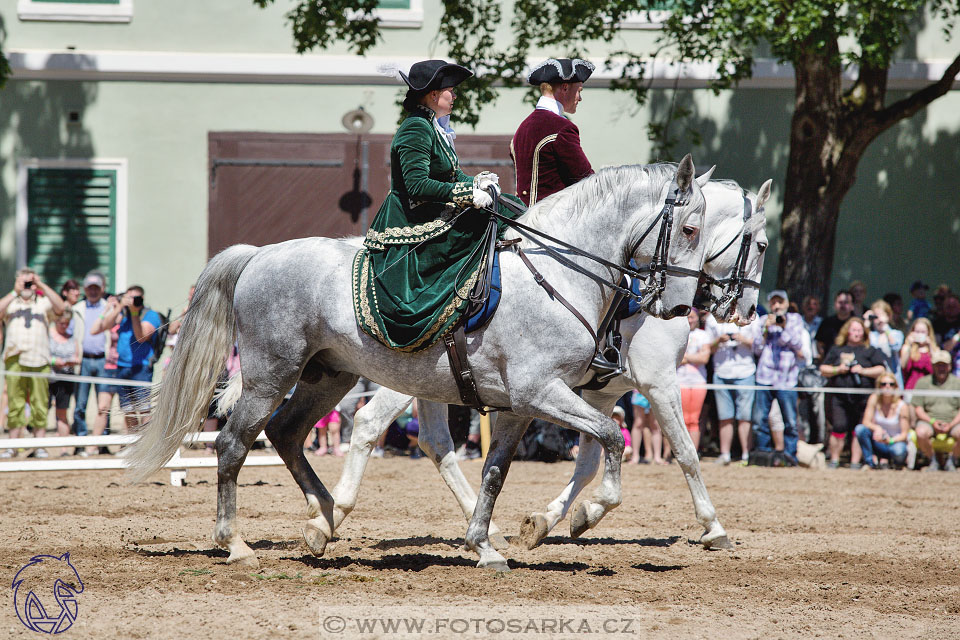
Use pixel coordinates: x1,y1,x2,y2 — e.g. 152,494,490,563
417,400,510,550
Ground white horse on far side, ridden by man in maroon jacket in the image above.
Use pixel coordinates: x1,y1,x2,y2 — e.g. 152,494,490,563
333,180,771,549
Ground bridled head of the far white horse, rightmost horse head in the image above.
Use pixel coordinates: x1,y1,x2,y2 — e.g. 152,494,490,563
696,180,773,326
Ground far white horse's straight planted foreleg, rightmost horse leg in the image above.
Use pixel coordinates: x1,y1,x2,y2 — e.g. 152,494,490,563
643,381,733,549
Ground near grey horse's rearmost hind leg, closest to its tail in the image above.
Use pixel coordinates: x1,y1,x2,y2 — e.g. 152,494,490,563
213,394,282,569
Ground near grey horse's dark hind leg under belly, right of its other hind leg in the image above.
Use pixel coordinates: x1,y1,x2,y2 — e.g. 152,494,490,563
267,373,357,556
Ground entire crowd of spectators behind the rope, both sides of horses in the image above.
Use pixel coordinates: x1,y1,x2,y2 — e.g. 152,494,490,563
0,269,960,471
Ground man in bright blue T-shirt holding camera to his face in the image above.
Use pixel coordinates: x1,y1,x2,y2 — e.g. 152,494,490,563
91,285,162,435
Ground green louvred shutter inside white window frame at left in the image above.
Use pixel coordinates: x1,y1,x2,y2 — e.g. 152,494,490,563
27,167,117,289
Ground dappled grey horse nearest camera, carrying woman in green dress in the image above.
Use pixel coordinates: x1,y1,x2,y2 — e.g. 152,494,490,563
128,156,709,569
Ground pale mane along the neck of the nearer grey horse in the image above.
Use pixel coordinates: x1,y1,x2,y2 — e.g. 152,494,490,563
520,162,703,228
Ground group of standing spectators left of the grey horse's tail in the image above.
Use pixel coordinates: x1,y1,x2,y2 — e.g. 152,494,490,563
0,268,166,458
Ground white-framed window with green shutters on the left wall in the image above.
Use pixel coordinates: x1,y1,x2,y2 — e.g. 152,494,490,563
17,160,126,289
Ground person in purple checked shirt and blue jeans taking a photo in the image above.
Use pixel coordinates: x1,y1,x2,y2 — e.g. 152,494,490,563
753,289,806,465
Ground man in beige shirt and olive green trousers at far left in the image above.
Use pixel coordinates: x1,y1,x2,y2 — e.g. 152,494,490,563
0,268,65,458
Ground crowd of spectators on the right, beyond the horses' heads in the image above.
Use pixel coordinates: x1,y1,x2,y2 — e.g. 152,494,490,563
620,281,960,471
